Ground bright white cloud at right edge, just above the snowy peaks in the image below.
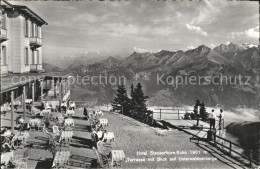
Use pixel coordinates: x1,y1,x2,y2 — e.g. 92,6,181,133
229,26,259,39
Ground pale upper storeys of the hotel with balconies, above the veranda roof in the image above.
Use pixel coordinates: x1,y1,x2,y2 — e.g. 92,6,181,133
0,0,47,76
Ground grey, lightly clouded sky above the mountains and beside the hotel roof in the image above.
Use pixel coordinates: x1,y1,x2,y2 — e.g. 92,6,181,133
12,0,259,57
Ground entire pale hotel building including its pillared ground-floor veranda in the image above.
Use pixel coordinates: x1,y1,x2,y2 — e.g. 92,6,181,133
0,0,70,131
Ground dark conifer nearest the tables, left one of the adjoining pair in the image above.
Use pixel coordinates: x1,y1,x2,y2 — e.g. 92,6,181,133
112,84,130,115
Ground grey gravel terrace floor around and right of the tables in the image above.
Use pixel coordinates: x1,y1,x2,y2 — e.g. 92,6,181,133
1,108,248,169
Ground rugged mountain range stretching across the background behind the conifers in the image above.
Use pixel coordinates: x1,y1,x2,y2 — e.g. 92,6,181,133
45,43,260,107
